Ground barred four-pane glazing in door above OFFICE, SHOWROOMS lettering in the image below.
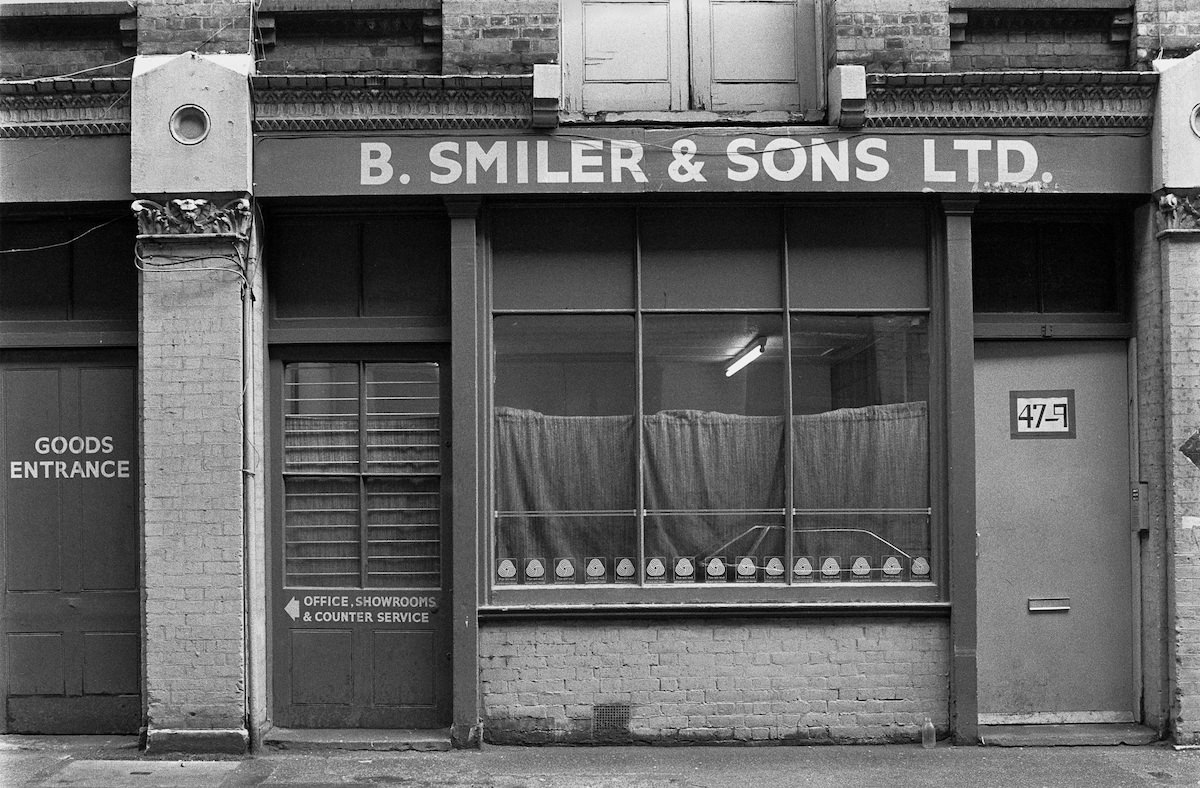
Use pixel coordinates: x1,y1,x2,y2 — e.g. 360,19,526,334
283,362,442,588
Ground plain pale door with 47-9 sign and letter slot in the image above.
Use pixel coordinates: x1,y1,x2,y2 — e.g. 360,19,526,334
976,341,1135,724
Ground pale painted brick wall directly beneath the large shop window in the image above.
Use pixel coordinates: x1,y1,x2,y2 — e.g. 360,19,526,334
480,618,949,744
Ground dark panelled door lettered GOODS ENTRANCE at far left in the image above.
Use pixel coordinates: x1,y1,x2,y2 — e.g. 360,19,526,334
0,351,142,734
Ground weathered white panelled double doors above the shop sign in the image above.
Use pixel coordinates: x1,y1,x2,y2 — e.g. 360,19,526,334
563,0,822,113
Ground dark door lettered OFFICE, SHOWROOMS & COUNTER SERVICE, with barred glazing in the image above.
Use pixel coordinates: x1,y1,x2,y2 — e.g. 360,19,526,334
271,360,450,728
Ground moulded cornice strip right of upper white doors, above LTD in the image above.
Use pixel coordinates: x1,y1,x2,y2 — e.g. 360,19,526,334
865,71,1158,128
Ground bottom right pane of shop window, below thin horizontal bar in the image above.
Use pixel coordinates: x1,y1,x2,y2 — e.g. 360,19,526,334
791,512,934,583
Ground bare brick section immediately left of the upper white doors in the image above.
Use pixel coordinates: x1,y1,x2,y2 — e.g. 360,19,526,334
442,0,558,74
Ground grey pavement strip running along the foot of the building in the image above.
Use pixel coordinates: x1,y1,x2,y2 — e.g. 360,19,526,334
0,735,1200,788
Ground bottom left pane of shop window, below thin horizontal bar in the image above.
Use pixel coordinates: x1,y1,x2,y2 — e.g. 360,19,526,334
492,512,637,585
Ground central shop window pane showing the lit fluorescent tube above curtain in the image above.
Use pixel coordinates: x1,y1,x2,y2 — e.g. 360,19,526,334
642,314,786,512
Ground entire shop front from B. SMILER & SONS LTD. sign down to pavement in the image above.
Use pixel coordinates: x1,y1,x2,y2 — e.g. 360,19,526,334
254,127,1150,742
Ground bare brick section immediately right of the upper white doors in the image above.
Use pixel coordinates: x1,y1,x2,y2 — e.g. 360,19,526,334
827,0,950,72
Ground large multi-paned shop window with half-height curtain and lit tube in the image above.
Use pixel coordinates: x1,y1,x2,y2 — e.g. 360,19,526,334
492,201,936,596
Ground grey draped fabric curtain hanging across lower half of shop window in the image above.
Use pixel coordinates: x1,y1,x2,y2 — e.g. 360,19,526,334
496,402,929,578
